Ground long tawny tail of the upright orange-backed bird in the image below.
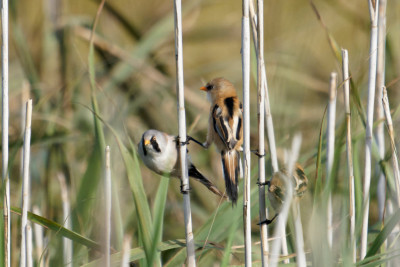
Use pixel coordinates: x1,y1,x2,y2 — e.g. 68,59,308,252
221,150,240,205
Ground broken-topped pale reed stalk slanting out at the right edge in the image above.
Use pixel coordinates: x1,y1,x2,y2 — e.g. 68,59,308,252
382,86,400,206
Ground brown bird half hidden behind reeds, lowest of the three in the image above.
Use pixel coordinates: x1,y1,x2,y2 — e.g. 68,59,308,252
259,163,308,224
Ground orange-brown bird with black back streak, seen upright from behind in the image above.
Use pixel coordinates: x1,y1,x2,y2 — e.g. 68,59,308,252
198,78,243,204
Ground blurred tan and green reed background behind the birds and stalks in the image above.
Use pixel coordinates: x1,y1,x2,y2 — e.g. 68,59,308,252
2,0,400,266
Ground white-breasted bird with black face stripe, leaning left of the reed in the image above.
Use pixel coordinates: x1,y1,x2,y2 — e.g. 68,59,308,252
138,130,225,197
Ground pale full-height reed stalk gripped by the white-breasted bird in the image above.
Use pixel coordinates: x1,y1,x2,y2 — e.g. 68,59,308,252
174,0,196,267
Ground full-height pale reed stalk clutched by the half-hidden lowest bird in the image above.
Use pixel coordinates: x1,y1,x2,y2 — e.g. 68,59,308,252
251,0,268,266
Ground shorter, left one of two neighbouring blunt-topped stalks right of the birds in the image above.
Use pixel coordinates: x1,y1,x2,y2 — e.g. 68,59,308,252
326,72,337,247
